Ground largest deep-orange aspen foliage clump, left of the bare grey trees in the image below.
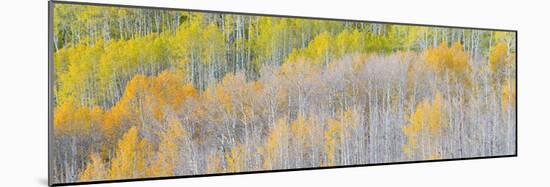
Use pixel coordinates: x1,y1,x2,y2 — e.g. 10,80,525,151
102,71,198,139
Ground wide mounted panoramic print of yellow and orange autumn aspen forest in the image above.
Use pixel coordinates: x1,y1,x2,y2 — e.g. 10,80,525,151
50,4,516,183
